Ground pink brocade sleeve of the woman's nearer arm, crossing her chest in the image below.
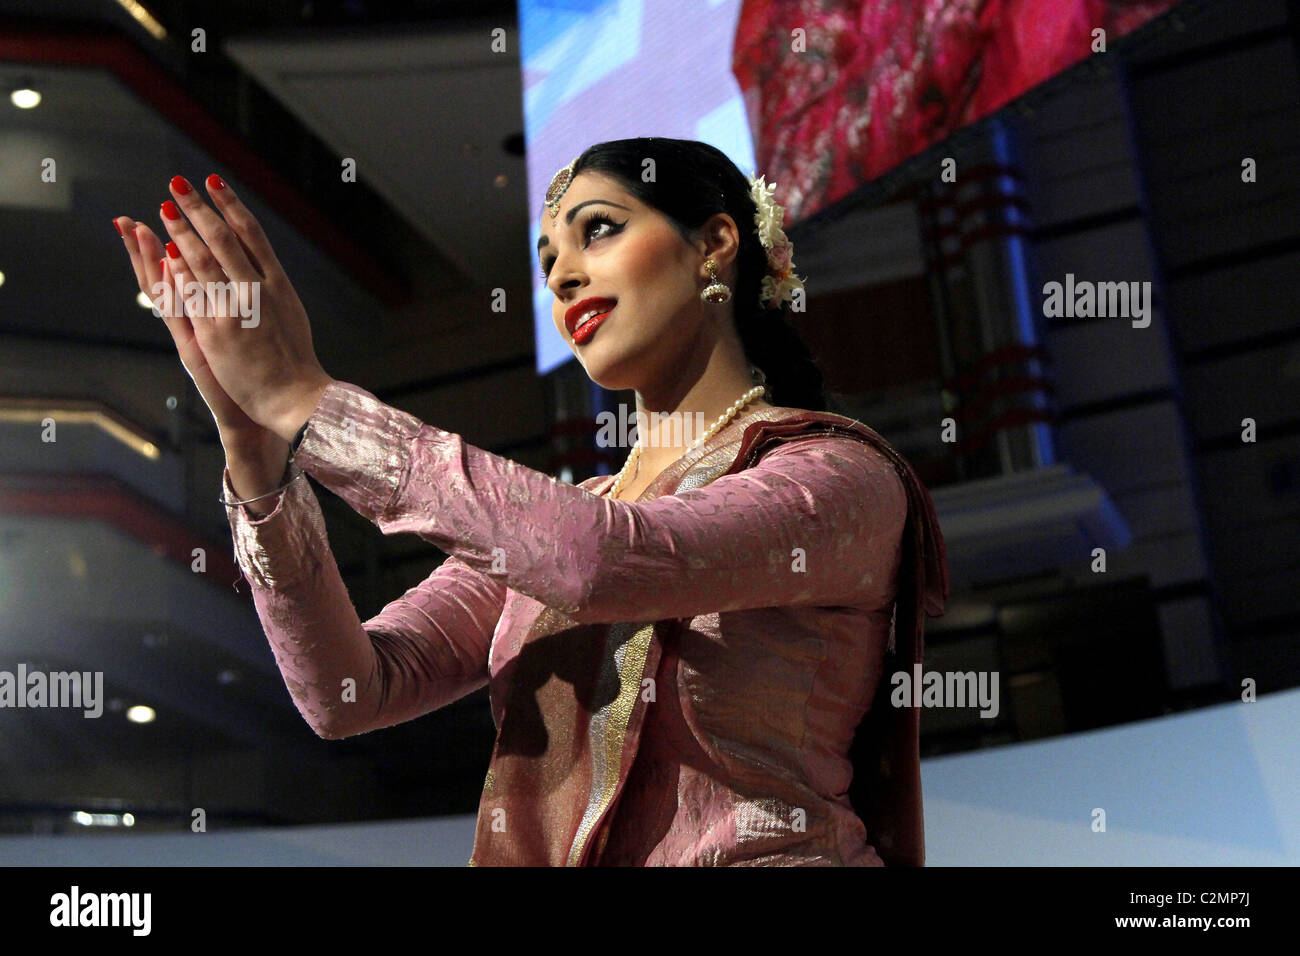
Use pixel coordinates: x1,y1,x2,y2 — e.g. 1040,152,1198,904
295,381,907,623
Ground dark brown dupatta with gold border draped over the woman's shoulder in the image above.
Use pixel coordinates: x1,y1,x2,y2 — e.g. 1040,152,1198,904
469,406,949,866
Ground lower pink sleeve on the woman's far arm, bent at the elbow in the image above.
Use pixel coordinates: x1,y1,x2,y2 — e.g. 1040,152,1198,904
222,470,506,739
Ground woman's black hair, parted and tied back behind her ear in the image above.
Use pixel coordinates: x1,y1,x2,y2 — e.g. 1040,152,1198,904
573,137,827,411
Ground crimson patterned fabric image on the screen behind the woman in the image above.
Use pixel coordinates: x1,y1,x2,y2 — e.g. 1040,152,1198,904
732,0,1179,225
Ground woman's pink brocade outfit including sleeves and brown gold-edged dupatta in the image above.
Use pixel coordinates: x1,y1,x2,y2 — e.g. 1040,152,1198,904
224,381,948,866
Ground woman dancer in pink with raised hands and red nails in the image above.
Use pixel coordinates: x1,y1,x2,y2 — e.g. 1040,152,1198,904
114,138,948,866
